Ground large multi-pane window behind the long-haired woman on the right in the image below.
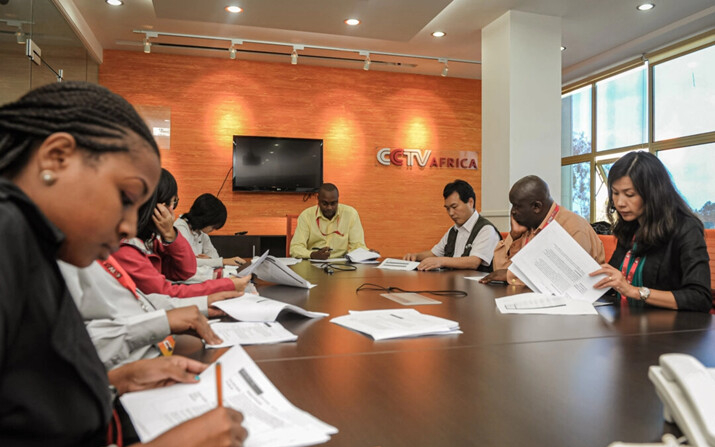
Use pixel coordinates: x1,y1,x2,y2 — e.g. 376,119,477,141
561,33,715,224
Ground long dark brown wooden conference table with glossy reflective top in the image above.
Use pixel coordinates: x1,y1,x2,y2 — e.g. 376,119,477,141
175,261,715,447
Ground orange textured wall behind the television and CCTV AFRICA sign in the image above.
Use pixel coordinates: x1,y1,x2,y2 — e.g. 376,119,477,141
99,51,481,256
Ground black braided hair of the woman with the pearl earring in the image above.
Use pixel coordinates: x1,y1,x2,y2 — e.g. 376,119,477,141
0,81,159,178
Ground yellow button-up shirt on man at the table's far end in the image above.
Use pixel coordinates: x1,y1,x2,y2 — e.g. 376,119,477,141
290,203,367,259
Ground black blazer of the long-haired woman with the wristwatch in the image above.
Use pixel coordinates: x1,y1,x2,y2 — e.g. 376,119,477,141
608,216,713,312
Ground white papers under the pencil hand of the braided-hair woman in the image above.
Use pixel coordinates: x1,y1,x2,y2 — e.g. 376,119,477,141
121,346,338,447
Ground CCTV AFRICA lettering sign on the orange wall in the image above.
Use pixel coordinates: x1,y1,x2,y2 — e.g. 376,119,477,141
377,147,478,169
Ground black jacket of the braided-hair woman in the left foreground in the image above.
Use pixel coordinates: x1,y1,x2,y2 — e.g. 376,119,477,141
0,178,111,447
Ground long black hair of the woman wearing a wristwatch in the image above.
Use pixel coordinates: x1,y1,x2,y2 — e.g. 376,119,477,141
608,152,702,256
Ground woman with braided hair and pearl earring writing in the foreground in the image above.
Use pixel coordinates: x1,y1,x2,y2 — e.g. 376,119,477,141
0,82,246,447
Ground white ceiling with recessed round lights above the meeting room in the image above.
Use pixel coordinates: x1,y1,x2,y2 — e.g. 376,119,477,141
23,0,715,83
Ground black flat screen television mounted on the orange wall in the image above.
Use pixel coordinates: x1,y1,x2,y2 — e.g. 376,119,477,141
233,135,323,193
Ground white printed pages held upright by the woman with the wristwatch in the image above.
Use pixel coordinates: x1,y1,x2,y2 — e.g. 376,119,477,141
509,221,606,303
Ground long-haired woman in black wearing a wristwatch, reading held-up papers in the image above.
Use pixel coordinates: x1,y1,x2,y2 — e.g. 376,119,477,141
591,152,712,312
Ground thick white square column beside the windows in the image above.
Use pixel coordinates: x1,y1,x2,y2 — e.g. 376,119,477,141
481,11,561,231
